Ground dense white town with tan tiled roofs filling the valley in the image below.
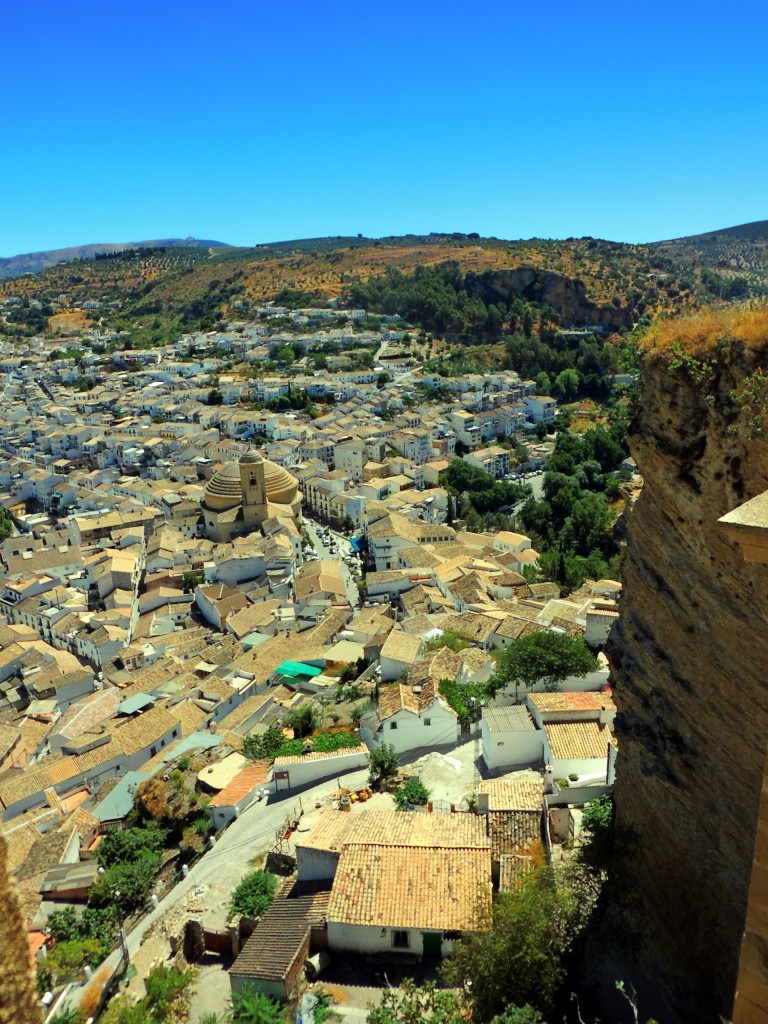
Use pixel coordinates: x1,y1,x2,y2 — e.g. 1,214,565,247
0,295,632,1022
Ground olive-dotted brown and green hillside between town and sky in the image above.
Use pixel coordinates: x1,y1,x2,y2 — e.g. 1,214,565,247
0,224,768,345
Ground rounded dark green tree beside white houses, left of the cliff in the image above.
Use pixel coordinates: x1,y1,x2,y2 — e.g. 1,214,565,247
492,630,597,690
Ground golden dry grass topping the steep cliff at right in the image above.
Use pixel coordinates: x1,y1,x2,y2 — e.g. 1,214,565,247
641,306,768,356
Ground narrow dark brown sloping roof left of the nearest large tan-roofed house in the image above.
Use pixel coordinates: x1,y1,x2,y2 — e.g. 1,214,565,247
229,881,331,981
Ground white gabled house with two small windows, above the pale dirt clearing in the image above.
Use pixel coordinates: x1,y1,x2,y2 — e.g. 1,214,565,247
360,681,459,754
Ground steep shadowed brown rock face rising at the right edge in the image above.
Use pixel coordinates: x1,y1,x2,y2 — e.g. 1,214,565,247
608,331,768,1022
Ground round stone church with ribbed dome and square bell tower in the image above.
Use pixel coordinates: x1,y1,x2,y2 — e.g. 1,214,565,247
200,452,301,543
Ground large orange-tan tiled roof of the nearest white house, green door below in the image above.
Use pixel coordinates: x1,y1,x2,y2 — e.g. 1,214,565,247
328,843,492,931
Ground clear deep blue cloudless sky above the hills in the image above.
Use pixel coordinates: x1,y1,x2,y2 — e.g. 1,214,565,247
0,0,768,256
